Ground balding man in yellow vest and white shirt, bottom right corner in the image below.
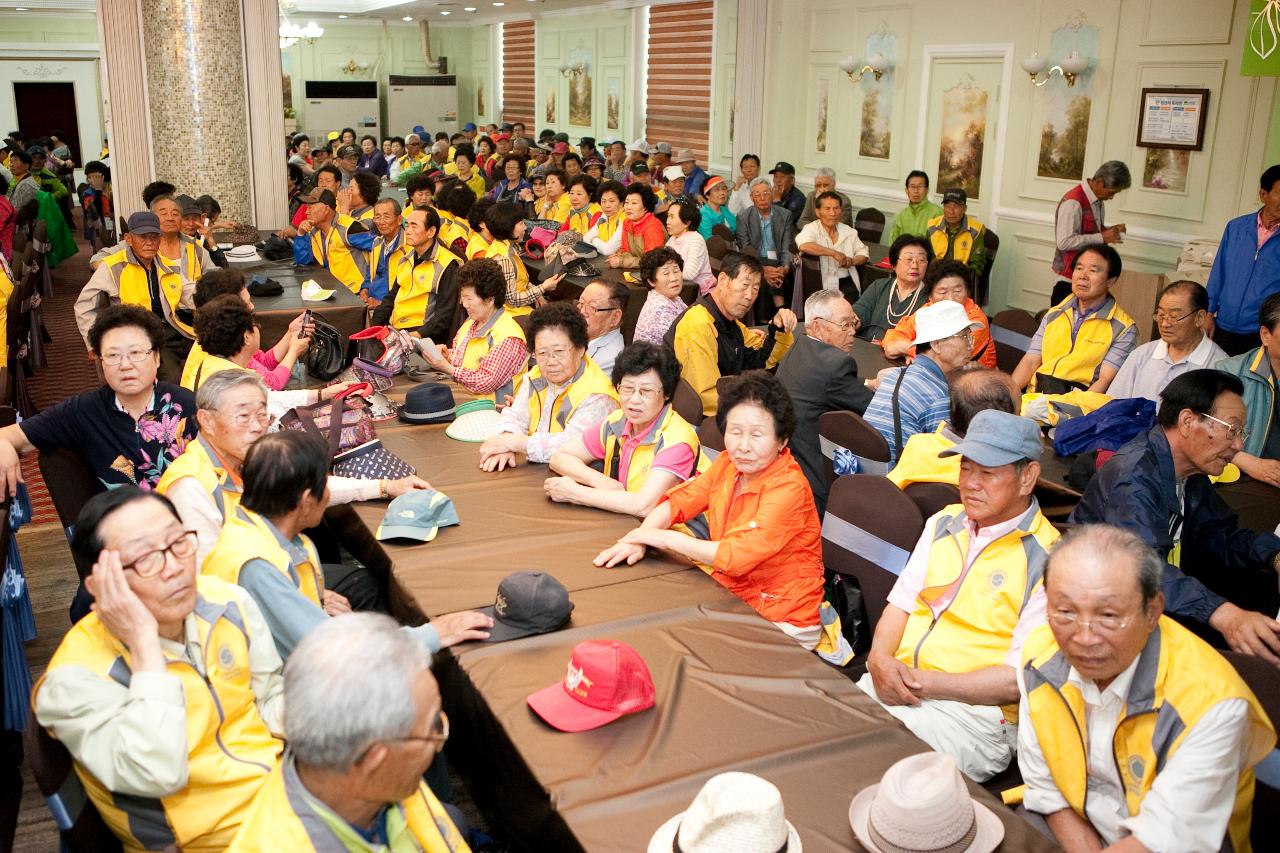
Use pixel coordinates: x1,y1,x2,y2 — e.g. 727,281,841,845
1018,525,1276,853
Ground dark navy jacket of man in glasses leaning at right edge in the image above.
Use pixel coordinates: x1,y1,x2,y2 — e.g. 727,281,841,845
1070,424,1280,624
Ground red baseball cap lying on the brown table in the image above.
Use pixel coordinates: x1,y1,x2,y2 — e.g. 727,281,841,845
527,640,654,731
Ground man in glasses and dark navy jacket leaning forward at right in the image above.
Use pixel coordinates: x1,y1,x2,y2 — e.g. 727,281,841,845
1071,370,1280,666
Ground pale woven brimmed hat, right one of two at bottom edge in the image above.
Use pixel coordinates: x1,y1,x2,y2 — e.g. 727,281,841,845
844,753,1005,853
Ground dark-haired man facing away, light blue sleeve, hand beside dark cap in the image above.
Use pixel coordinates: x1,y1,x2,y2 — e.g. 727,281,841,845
204,430,492,658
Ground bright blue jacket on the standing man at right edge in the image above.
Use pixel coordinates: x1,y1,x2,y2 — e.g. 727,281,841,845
1206,211,1280,334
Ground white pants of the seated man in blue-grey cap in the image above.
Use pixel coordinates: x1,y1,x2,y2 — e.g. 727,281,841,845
858,672,1018,783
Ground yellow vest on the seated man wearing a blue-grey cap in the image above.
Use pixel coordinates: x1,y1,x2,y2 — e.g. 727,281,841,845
893,503,1060,721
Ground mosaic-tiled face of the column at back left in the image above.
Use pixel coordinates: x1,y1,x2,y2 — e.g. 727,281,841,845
140,0,253,222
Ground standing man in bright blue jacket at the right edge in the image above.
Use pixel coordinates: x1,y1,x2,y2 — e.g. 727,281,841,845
1208,163,1280,356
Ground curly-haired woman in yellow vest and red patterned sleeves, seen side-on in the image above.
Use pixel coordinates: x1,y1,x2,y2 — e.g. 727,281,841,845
422,256,529,401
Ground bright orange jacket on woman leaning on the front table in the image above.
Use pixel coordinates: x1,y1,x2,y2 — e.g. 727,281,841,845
663,450,822,628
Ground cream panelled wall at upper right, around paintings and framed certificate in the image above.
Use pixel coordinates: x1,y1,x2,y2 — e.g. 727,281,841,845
747,0,1276,310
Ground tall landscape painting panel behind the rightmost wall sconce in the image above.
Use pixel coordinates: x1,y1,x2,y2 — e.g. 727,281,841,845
1036,12,1098,181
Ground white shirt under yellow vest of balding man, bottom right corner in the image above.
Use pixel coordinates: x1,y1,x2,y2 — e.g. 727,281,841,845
1018,657,1249,853
